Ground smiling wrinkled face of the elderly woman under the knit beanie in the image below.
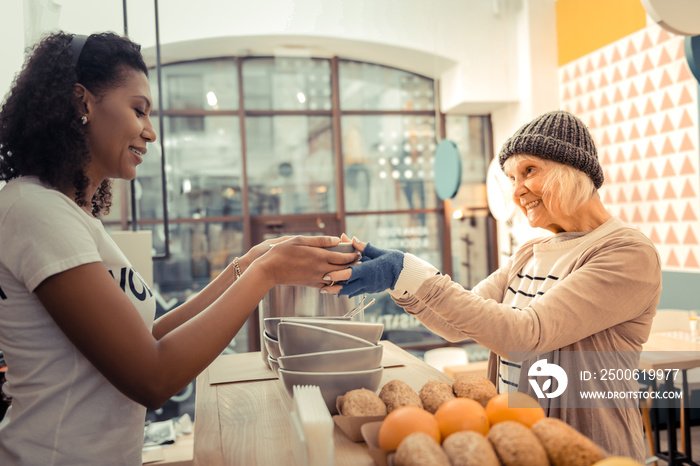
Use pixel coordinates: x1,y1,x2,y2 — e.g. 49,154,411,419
506,156,565,233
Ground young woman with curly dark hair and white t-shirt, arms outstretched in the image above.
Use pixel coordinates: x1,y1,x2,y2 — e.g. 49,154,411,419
0,33,357,465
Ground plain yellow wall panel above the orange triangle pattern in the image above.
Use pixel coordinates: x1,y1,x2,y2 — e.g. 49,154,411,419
555,0,647,66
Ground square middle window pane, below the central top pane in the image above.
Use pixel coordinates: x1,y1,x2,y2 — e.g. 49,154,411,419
246,116,337,215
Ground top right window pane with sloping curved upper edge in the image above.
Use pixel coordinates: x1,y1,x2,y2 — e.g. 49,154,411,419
339,61,435,110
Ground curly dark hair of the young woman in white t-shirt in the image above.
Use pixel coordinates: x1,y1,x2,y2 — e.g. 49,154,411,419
0,32,148,216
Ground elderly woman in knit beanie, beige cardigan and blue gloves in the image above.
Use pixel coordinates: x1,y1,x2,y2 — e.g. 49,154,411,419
324,111,661,460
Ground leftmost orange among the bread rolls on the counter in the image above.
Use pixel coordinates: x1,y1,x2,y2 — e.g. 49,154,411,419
379,406,440,450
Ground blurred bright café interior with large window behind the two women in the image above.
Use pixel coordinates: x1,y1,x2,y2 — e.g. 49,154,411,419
0,0,700,462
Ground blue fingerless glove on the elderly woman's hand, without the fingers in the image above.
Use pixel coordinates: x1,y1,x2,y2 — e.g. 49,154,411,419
338,243,404,297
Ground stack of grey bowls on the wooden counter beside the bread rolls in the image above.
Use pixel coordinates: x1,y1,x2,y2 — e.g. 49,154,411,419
263,317,384,413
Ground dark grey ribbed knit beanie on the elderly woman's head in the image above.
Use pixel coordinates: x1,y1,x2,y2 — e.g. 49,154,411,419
498,111,604,189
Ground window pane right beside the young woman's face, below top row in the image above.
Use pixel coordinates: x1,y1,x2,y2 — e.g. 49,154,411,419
136,116,243,223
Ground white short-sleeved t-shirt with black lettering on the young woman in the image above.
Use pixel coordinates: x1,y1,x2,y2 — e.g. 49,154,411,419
0,177,155,466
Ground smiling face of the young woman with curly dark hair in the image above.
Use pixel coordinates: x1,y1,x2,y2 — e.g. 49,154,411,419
83,69,156,186
